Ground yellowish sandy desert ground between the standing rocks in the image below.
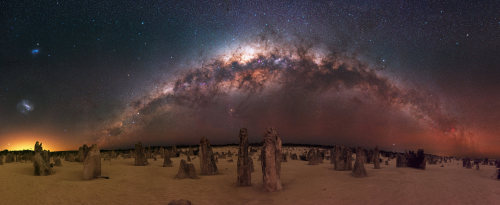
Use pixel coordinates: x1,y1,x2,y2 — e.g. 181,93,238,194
0,147,500,205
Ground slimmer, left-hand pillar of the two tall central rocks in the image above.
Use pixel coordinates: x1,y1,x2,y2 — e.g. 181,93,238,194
237,128,253,186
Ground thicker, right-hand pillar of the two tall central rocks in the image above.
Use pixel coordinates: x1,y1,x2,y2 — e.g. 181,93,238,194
261,128,282,192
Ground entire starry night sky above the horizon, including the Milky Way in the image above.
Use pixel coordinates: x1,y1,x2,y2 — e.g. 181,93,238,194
0,0,500,156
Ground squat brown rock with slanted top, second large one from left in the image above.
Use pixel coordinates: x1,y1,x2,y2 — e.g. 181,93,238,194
83,144,101,180
